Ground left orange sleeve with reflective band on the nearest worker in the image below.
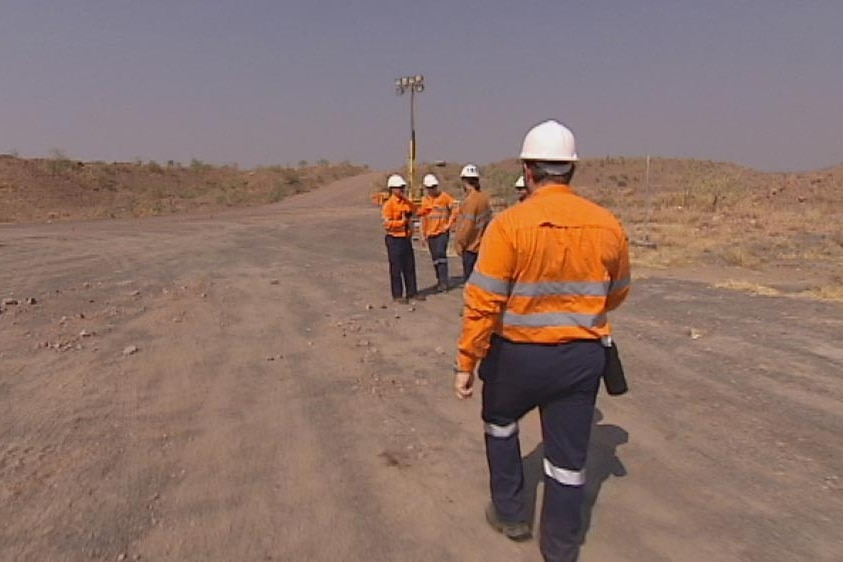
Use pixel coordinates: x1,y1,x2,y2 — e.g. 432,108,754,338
457,220,516,372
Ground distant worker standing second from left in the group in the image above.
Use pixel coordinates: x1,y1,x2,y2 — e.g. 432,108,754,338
417,174,456,292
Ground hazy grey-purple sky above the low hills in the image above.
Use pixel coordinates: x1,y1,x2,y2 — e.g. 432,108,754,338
0,0,843,171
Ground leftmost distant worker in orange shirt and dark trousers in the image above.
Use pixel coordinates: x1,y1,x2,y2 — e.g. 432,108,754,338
381,174,424,304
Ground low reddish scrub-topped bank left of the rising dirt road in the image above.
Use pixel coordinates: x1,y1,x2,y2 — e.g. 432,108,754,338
0,155,365,222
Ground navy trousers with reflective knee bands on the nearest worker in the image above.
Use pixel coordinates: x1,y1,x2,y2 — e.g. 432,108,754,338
479,336,606,562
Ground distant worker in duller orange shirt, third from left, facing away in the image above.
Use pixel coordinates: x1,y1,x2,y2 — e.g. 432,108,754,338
456,164,492,281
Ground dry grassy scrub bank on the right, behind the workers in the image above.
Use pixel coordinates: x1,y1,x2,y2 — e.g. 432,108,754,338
418,156,843,295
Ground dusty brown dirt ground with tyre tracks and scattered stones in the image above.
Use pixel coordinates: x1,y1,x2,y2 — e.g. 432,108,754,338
0,175,843,562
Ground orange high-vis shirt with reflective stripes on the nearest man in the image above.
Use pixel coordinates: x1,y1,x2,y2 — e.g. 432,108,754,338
457,184,630,372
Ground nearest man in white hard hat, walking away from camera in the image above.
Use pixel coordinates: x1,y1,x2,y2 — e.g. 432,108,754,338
454,121,630,562
